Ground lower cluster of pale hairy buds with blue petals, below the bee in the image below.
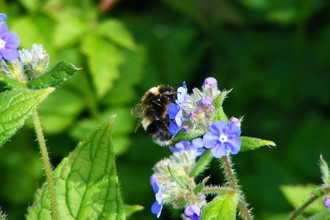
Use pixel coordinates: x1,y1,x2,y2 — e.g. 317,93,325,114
150,148,206,220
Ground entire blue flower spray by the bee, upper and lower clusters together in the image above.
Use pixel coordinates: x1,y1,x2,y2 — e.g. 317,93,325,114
150,77,242,220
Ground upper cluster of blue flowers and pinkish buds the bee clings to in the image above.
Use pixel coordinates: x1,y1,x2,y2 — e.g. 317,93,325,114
168,77,242,158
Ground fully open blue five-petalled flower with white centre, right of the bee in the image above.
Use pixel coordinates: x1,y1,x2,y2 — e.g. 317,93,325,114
203,121,242,158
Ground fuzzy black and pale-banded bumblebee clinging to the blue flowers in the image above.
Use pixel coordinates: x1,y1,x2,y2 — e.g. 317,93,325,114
131,85,176,146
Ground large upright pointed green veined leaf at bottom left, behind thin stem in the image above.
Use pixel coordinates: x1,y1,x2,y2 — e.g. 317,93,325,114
27,116,125,220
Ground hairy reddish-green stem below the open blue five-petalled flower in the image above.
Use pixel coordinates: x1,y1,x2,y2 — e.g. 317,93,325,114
220,156,253,220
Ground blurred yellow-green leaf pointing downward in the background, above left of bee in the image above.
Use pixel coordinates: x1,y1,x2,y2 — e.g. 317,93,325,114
81,34,123,98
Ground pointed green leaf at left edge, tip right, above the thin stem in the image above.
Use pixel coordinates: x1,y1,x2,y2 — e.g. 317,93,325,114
0,88,54,146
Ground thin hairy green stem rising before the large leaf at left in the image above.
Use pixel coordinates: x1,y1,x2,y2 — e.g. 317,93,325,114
32,109,59,220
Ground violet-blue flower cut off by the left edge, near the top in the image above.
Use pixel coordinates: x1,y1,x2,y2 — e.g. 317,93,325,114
0,22,19,61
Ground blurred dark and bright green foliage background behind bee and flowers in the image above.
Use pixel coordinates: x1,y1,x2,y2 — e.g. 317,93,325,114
0,0,330,220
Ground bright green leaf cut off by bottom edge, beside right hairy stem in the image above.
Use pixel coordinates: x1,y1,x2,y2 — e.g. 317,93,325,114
200,192,238,220
